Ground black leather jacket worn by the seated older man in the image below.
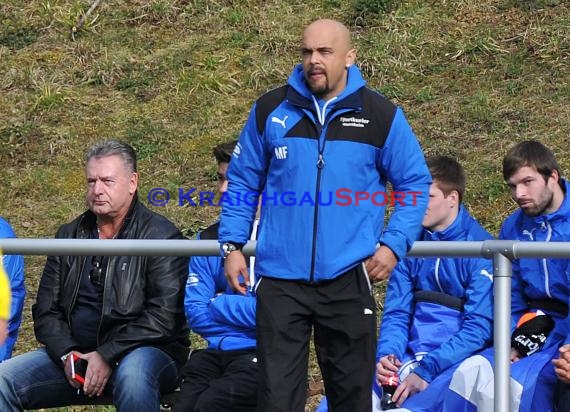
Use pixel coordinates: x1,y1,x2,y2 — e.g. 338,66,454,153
32,199,190,367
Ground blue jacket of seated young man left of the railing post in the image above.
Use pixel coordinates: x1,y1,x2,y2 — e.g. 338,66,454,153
376,207,493,382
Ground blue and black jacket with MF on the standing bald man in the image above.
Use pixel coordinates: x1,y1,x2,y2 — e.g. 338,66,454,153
220,65,431,282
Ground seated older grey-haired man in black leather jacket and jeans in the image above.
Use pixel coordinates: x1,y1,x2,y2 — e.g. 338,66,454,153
0,140,189,412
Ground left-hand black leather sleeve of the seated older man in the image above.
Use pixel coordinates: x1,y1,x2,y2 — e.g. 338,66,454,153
32,227,79,362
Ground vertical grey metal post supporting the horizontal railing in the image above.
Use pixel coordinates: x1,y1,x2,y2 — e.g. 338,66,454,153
493,252,512,412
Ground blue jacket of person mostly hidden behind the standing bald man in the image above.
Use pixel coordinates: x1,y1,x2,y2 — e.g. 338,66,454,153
184,223,255,350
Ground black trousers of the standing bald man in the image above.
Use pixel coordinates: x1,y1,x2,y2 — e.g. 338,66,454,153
256,265,377,412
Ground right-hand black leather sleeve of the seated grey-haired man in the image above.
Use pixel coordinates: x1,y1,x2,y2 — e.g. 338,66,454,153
97,227,188,364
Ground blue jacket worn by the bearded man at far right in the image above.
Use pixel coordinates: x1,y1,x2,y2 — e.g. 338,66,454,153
499,180,570,346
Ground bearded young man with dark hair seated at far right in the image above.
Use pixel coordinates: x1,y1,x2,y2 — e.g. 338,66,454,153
445,140,570,412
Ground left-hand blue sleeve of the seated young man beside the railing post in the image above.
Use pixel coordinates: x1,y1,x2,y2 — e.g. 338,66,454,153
376,259,414,361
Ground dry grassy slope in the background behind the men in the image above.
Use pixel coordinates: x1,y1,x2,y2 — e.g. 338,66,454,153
0,0,570,408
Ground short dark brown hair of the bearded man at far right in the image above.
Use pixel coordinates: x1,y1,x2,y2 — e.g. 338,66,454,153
503,140,560,181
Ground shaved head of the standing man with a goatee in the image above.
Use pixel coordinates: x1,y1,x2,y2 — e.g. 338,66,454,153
301,19,356,100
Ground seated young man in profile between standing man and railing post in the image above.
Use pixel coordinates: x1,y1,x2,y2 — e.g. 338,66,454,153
374,156,493,411
